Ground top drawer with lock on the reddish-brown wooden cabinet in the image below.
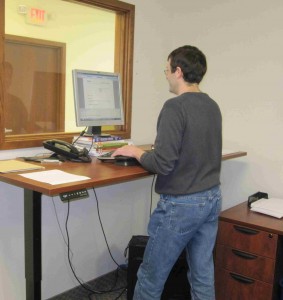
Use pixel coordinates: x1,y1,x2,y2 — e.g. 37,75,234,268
217,221,278,258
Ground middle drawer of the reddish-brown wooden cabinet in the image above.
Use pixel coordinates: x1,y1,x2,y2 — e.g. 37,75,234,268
216,244,275,284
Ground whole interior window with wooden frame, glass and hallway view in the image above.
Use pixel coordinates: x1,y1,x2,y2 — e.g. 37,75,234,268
0,0,134,149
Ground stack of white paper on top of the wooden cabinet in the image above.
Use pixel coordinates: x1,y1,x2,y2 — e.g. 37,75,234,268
251,198,283,219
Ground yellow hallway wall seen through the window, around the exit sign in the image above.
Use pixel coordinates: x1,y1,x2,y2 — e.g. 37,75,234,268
5,0,115,131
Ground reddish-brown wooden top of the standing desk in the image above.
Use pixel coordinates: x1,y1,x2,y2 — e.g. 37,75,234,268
0,151,247,196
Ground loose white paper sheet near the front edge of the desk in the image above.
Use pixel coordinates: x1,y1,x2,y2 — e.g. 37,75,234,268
19,170,90,185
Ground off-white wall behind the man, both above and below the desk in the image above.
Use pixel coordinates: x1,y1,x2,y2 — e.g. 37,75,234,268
0,0,283,300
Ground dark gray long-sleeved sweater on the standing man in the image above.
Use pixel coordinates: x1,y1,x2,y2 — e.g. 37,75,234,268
141,93,222,195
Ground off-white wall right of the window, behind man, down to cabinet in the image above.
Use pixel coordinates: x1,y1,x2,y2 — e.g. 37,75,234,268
129,0,283,208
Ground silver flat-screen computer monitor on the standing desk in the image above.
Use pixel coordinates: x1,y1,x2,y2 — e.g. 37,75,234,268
72,70,124,135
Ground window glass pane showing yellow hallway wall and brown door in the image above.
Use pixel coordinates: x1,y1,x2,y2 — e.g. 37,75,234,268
5,0,115,135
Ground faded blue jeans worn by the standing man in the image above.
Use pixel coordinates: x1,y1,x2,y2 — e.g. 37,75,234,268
133,186,222,300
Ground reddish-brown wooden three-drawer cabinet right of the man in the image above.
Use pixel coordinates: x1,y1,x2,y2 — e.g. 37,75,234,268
215,203,283,300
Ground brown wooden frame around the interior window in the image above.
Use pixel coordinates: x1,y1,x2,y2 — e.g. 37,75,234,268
0,0,135,150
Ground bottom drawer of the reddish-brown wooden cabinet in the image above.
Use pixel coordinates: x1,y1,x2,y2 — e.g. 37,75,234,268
215,268,272,300
